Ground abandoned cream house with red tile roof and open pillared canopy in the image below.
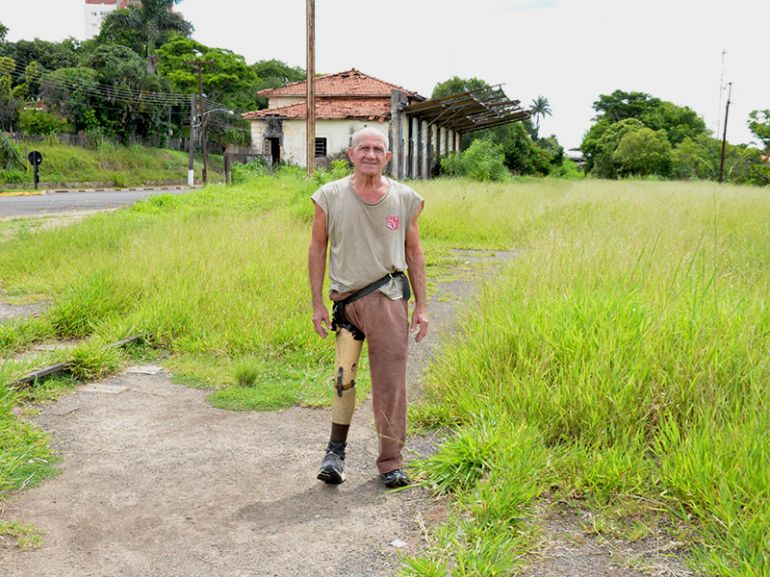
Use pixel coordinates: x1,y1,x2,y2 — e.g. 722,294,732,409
243,68,529,178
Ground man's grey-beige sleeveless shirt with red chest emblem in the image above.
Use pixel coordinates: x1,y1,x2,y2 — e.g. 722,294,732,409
311,176,423,300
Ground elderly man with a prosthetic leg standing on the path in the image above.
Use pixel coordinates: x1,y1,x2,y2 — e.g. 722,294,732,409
308,128,428,488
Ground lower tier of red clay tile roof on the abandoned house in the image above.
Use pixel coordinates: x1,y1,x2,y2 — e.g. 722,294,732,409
242,98,390,122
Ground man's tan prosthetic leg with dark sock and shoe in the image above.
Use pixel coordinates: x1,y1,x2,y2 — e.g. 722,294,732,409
318,327,364,484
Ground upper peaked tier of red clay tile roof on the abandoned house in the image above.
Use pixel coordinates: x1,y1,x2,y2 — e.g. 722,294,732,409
257,68,424,100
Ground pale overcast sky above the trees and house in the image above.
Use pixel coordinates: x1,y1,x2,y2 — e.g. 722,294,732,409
0,0,770,148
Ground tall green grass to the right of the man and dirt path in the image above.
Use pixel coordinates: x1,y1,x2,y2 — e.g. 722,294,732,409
405,181,770,576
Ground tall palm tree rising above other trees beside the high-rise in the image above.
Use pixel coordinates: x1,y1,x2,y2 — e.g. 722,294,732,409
98,0,193,75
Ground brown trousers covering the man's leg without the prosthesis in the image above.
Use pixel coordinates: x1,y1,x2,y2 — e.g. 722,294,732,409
334,291,409,473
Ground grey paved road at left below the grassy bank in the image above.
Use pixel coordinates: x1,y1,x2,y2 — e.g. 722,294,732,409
0,188,191,218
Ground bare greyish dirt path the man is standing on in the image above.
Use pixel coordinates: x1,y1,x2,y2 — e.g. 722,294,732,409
0,253,688,577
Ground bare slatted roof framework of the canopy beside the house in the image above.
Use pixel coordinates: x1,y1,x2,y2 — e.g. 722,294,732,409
403,85,531,133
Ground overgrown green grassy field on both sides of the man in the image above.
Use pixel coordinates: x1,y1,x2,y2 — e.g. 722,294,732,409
0,174,770,577
